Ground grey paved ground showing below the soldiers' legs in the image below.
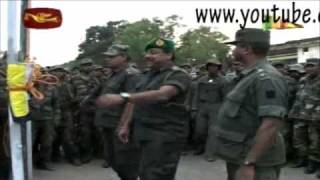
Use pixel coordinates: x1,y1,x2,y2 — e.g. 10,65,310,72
34,155,317,180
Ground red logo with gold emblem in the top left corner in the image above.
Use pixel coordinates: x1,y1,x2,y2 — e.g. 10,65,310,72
22,8,62,29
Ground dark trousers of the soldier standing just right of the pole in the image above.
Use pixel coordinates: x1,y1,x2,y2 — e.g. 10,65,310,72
32,120,55,162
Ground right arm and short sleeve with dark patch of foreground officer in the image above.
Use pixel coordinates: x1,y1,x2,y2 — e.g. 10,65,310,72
246,75,288,163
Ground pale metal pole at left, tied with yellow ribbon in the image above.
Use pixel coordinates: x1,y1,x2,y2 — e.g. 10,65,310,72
7,0,32,180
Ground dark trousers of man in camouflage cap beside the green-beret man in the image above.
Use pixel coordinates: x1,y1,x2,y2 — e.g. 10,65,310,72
104,128,141,180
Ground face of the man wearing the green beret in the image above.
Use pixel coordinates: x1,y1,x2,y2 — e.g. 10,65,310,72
144,48,172,69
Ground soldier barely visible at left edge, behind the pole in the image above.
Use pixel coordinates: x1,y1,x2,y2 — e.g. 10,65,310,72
0,52,10,180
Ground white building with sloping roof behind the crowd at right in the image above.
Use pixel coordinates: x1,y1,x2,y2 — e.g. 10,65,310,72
268,36,320,64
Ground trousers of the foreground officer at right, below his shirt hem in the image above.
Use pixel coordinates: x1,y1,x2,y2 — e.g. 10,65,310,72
226,163,281,180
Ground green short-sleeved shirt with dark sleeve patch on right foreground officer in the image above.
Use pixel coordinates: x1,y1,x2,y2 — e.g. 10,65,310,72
215,60,288,166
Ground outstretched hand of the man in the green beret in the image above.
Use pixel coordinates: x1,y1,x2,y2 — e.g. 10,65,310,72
96,94,124,107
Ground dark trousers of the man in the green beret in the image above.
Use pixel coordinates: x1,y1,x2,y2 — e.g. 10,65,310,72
140,141,184,180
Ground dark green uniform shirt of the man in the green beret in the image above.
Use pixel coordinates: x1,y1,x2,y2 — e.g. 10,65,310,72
134,66,191,141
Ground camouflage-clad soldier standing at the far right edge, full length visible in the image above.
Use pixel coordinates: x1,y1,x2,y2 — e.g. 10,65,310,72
290,58,320,178
